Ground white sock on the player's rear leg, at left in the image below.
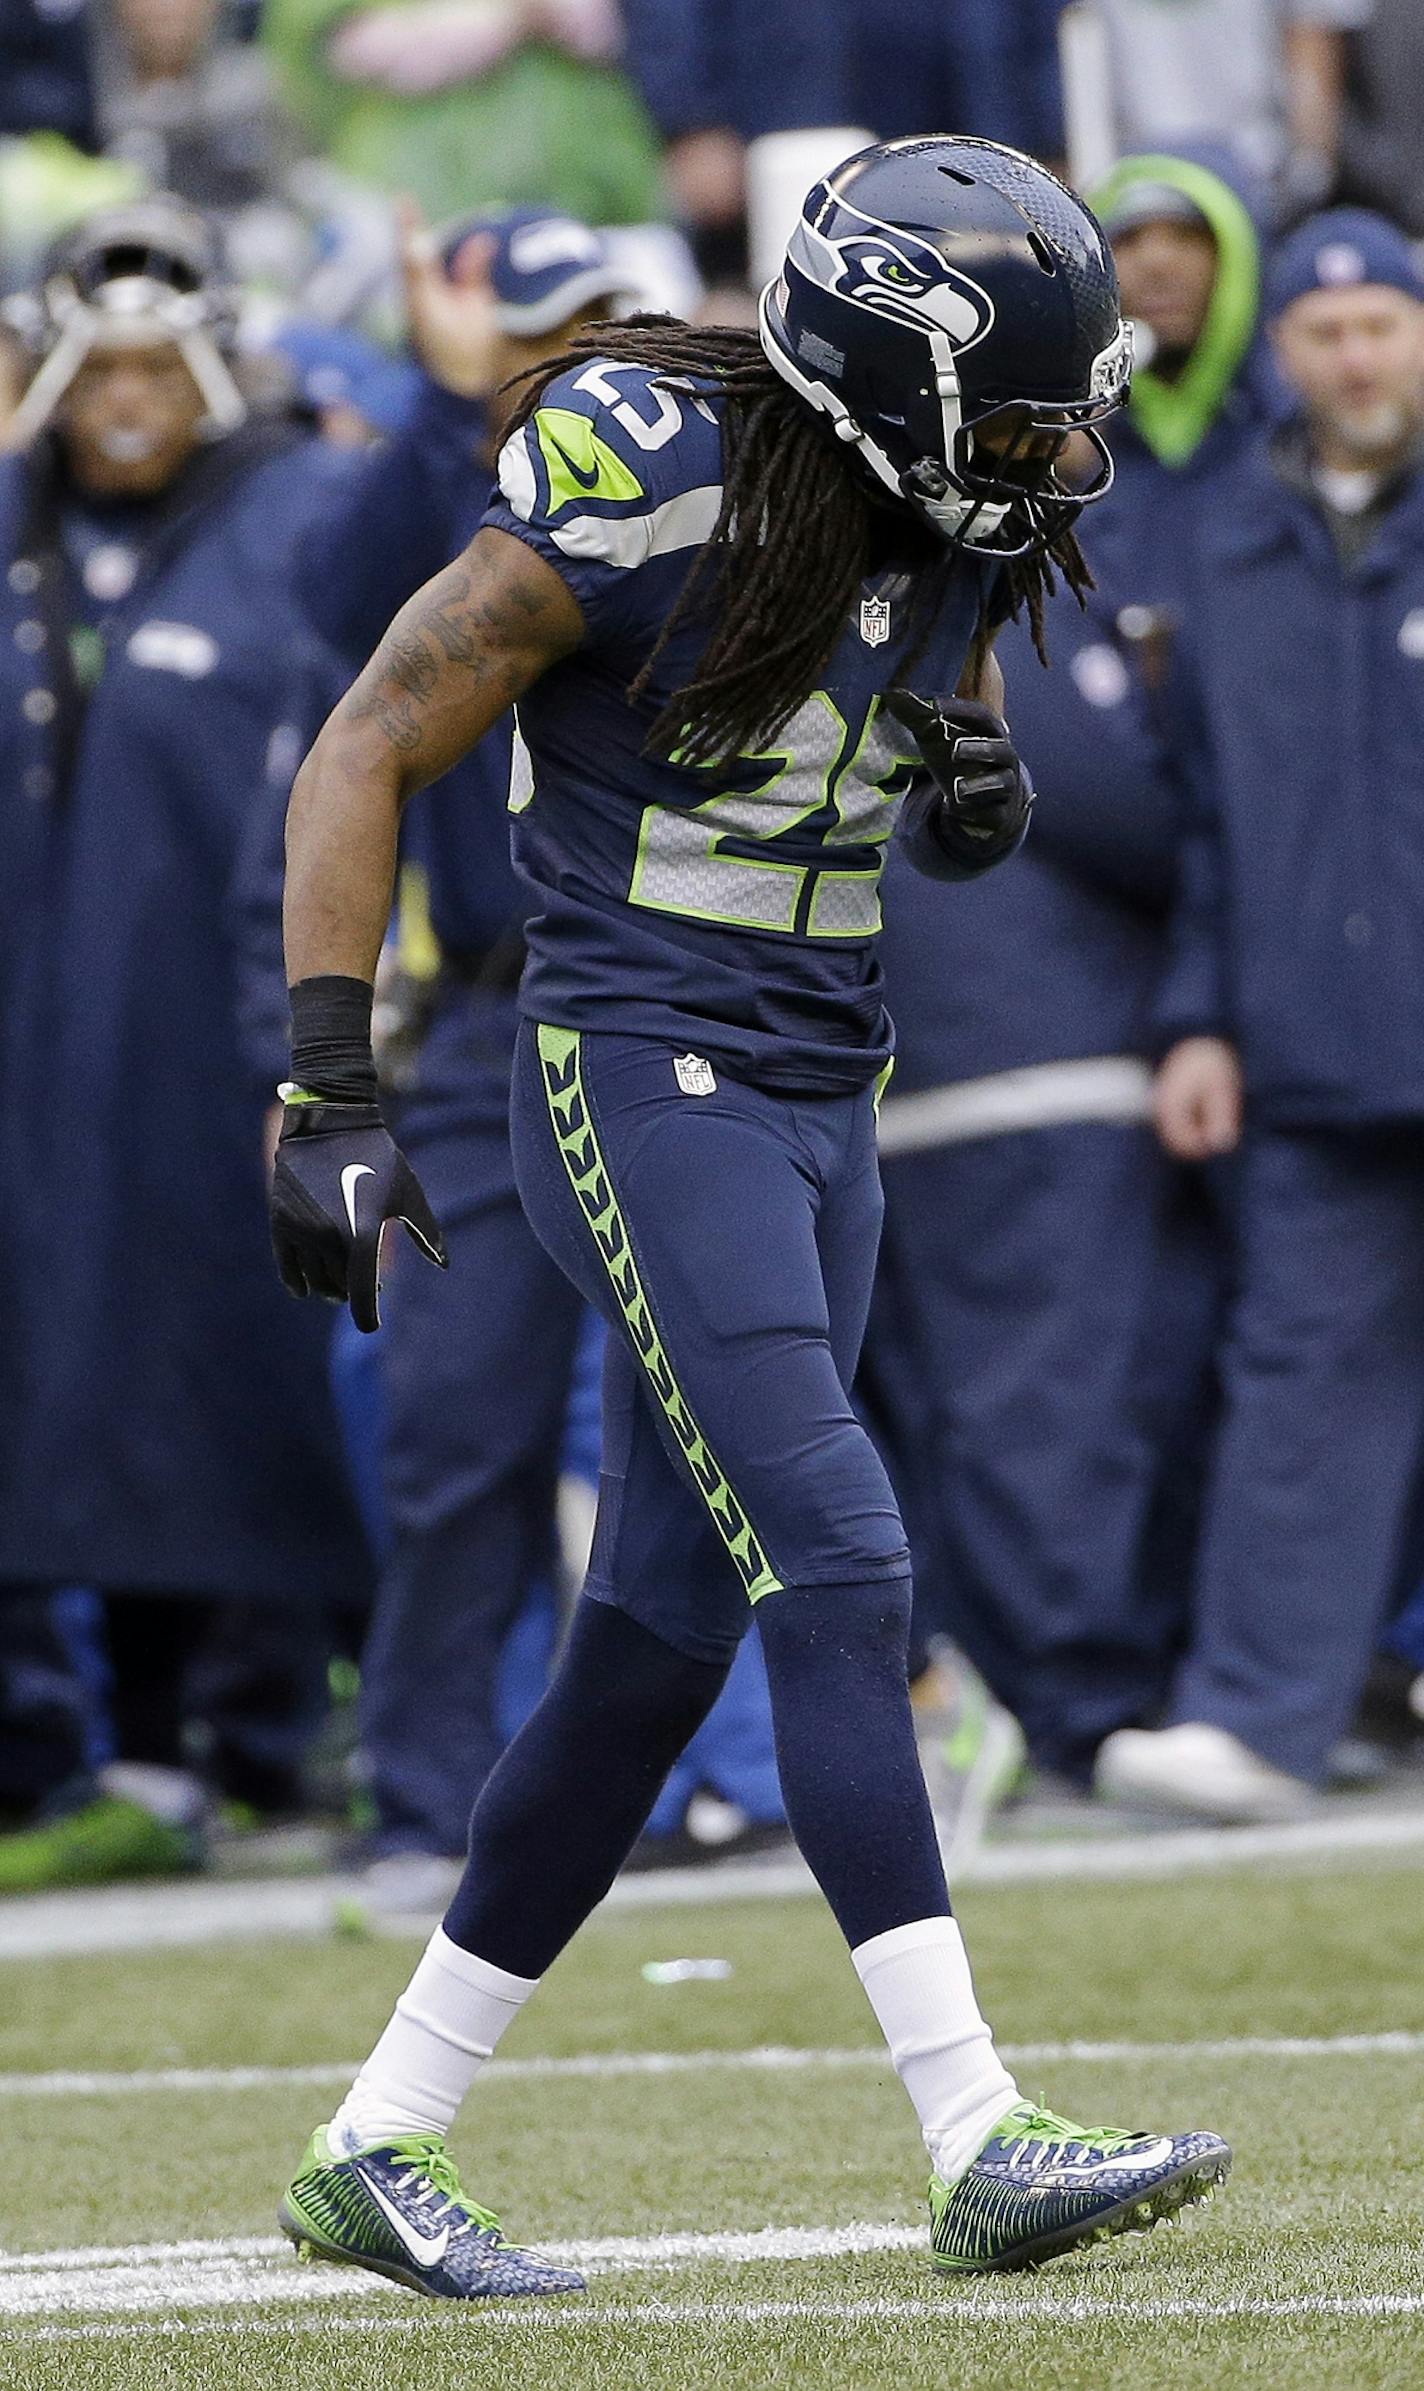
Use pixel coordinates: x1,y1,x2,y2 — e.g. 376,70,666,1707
327,1927,538,2157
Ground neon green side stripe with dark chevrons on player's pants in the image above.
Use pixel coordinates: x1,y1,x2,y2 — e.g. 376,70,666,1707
538,1023,781,1602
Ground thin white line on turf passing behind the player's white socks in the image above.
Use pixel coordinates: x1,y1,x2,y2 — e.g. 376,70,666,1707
0,2032,1424,2104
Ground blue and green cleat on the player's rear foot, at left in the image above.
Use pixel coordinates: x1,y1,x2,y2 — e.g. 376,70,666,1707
277,2128,588,2300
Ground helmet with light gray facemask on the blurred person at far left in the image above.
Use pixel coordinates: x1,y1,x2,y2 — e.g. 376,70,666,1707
7,198,246,447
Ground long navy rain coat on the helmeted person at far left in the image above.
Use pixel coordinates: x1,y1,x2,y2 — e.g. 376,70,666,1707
0,428,368,1600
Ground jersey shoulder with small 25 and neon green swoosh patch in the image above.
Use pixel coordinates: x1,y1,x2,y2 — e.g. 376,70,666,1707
499,359,722,569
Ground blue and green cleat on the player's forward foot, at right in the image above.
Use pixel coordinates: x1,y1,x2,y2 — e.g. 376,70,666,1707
929,2102,1230,2274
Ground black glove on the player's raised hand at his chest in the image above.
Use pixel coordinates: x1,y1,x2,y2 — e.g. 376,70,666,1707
884,689,1035,880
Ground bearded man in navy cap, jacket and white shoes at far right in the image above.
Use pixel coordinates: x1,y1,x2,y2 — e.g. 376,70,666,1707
1099,210,1424,1820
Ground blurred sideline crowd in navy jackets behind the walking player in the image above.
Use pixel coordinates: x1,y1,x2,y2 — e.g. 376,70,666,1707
0,0,1424,1908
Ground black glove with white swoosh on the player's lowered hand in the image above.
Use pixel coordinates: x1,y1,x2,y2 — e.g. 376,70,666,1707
272,1102,449,1329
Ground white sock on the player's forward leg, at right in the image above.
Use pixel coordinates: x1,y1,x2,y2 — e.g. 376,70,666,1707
851,1918,1018,2183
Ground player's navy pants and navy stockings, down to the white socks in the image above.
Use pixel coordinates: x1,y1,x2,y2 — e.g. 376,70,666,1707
447,1026,949,1975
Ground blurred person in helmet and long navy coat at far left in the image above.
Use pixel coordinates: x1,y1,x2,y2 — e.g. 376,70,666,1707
0,198,368,1891
